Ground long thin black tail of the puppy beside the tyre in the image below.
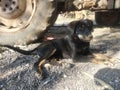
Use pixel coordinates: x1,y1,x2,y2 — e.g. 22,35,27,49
1,45,37,55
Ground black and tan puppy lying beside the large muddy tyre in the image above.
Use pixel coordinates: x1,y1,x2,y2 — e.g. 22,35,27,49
2,19,93,74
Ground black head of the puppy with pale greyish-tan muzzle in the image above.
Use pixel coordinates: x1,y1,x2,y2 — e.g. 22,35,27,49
73,19,93,42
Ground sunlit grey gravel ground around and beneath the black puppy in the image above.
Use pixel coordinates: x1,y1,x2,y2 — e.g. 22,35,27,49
0,12,120,90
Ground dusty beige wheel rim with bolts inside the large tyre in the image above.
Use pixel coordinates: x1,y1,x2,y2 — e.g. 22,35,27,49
0,0,37,33
